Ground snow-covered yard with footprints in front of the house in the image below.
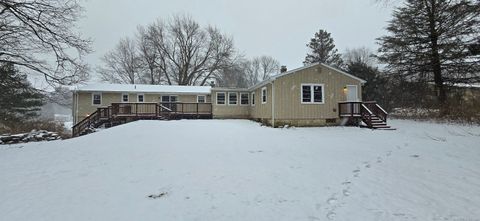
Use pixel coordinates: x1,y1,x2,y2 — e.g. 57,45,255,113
0,120,480,221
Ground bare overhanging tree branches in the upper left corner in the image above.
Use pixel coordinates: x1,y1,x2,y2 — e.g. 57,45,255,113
0,0,91,84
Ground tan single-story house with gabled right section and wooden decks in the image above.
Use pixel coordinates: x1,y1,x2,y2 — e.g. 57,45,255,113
73,63,388,135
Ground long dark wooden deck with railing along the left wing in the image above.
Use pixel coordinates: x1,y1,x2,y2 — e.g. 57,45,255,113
72,103,212,137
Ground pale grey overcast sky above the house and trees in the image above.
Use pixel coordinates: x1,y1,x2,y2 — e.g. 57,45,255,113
79,0,391,78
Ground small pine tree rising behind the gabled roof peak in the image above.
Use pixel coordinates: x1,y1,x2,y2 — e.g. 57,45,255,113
303,29,343,67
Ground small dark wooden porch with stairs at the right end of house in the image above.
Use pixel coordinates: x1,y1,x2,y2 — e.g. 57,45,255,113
339,101,395,130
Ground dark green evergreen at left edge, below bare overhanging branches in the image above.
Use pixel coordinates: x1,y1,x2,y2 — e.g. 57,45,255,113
0,63,43,126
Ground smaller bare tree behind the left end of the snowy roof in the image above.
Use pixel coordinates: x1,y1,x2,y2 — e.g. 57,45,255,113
98,38,140,84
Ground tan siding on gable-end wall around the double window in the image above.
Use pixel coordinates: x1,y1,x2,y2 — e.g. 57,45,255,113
275,66,361,121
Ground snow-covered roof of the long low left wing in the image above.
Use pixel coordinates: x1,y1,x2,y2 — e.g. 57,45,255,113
75,83,211,94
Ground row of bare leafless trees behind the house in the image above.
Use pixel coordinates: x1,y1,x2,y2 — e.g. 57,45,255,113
97,15,280,87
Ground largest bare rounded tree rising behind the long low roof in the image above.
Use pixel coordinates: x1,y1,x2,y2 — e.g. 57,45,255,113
122,15,236,85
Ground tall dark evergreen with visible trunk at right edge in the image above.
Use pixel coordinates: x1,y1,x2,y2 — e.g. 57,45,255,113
378,0,480,114
